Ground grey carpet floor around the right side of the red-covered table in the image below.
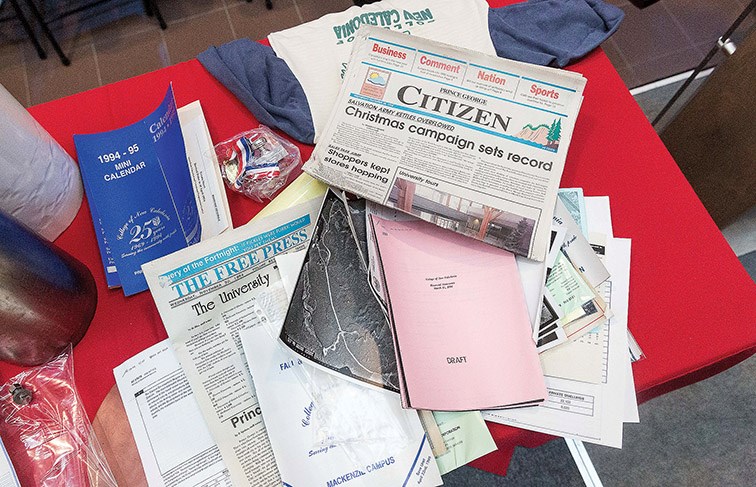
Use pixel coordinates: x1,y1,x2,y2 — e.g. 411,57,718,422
444,81,756,487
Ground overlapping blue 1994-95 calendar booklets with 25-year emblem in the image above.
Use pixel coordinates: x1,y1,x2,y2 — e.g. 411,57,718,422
74,87,202,296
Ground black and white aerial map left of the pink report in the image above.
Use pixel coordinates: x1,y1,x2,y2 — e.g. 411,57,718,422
280,192,399,391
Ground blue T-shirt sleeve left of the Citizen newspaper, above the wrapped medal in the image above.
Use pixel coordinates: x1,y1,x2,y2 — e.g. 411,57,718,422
197,39,315,144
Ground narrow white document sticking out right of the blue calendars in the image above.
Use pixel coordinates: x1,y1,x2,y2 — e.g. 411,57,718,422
178,100,232,240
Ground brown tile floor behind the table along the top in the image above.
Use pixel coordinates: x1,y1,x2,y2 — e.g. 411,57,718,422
0,0,754,106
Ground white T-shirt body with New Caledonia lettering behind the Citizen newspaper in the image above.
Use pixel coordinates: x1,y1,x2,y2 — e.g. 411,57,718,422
268,0,496,141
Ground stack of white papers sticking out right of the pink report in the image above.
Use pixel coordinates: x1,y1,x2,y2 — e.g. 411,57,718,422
484,195,638,448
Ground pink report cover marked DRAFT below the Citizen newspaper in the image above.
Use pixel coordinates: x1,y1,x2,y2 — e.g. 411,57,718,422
371,216,546,411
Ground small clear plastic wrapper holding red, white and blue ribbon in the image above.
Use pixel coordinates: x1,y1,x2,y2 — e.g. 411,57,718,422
215,125,302,202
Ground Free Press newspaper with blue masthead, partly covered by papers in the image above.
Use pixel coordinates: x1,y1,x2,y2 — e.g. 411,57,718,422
142,198,320,487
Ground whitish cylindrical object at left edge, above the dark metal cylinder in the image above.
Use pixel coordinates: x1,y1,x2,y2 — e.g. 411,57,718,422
0,86,84,241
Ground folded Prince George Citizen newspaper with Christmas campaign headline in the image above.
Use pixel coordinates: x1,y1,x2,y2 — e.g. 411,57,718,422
304,27,585,261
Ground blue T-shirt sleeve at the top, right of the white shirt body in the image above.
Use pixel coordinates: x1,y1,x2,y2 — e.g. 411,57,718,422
488,0,625,68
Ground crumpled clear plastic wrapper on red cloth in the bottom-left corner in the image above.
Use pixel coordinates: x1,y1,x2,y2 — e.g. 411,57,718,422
0,346,116,487
